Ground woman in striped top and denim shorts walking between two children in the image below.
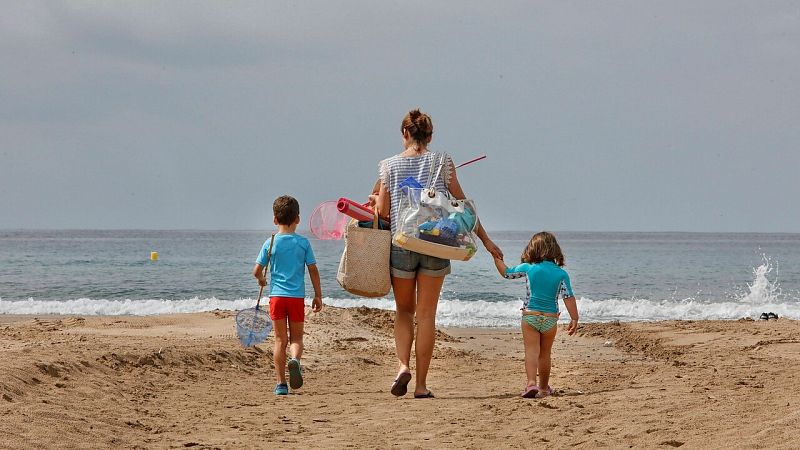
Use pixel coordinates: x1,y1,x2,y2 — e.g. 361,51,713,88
370,109,503,398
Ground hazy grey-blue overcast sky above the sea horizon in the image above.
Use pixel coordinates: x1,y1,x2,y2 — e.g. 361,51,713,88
0,0,800,232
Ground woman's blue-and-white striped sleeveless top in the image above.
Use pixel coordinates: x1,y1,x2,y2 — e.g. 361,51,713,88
378,151,454,234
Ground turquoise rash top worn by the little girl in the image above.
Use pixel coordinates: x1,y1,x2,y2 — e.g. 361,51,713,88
505,261,574,313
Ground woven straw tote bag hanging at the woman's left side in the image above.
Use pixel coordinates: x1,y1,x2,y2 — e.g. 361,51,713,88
336,216,392,297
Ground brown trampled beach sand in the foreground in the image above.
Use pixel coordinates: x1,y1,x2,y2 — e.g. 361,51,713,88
0,307,800,448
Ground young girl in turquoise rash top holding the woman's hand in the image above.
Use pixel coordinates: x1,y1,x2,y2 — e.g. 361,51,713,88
494,231,578,398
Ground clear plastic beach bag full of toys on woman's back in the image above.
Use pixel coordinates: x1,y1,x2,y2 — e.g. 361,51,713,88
392,154,478,261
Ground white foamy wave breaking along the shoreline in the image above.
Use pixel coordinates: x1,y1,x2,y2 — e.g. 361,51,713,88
0,298,800,327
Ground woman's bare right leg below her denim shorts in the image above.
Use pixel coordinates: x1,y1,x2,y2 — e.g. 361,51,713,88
414,274,444,394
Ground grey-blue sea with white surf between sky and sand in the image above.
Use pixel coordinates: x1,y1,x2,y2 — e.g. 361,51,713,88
0,230,800,326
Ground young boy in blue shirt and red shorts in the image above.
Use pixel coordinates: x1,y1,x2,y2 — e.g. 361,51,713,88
253,195,322,395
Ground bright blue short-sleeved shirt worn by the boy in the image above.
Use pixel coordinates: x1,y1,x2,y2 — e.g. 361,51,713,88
256,233,317,298
